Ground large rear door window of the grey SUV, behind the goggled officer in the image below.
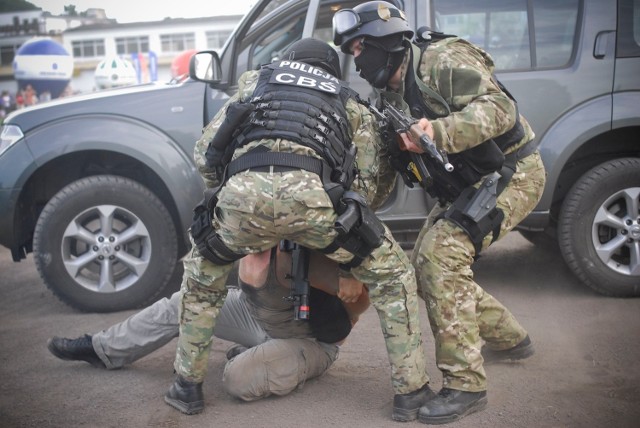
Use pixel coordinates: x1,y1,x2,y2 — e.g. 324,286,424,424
431,0,582,70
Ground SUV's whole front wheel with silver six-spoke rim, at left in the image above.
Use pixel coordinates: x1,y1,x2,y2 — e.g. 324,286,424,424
33,175,177,312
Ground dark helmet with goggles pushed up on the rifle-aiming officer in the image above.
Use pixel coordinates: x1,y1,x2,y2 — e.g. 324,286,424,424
333,1,413,54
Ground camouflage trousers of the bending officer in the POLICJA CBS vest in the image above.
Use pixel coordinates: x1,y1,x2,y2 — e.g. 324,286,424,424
174,171,429,394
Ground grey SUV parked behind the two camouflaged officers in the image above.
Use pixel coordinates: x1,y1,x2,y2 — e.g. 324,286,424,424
0,0,640,312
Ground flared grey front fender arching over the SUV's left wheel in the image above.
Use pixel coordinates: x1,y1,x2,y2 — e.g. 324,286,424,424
15,117,203,255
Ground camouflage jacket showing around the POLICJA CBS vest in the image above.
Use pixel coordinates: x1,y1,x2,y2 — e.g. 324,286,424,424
194,71,395,209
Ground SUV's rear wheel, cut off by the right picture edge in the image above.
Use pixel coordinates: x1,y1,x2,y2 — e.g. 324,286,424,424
558,158,640,297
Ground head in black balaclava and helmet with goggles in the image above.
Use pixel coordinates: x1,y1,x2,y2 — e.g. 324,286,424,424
333,1,413,88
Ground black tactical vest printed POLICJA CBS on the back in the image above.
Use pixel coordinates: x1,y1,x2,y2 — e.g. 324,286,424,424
220,60,356,189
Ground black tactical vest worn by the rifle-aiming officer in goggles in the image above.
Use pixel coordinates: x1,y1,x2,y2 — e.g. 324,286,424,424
404,35,525,202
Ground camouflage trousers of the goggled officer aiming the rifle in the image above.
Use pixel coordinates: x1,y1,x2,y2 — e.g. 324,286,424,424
412,152,545,392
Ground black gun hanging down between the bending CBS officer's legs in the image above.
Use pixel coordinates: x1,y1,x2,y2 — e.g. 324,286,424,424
280,240,309,320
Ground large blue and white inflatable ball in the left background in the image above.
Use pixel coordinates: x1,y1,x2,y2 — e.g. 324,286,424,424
13,37,73,98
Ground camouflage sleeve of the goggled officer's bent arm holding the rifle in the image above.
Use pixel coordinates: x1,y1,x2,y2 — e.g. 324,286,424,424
419,38,516,153
